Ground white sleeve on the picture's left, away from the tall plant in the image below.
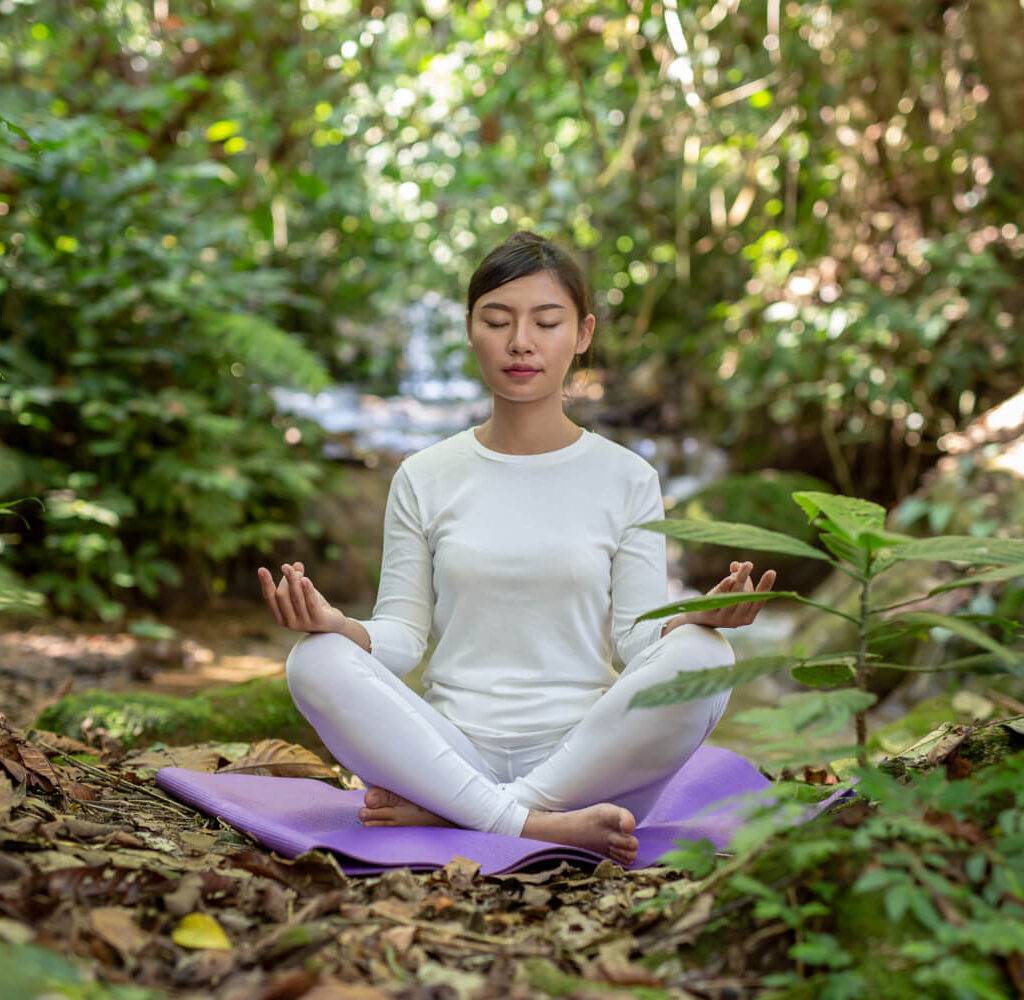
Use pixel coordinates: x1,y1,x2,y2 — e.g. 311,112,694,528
352,465,434,677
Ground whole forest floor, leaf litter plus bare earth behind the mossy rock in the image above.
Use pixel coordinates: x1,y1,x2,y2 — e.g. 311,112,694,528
0,605,1020,1000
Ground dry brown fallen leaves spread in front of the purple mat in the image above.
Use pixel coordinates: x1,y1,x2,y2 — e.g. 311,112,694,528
0,708,720,1000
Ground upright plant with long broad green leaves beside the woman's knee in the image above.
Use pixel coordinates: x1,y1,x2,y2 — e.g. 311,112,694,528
630,490,1024,765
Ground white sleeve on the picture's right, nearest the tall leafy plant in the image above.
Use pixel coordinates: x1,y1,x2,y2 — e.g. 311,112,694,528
611,468,669,665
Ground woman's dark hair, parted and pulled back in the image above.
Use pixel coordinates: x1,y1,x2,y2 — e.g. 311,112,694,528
466,229,594,396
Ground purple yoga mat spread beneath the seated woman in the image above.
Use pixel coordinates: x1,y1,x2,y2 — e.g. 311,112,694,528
157,743,856,875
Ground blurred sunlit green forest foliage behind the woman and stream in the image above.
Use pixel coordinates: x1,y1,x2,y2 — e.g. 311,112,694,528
0,0,1024,621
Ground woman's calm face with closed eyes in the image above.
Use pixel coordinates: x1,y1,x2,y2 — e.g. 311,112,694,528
467,271,597,399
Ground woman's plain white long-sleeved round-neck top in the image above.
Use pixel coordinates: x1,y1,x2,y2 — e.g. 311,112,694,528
355,428,669,748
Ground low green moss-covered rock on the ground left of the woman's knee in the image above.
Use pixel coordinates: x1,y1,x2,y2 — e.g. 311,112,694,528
35,678,324,752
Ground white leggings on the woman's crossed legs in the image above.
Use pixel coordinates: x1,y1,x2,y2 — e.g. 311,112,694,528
286,625,735,836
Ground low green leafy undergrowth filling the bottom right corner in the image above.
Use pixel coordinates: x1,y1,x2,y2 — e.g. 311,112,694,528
634,752,1024,1000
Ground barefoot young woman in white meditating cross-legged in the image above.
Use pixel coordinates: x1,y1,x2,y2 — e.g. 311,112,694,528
258,232,775,865
